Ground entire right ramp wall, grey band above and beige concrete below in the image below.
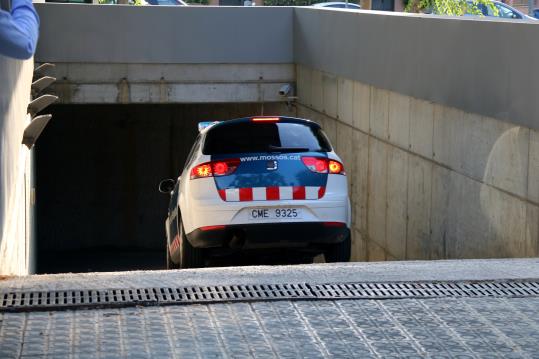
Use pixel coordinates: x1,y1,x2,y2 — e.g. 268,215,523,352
294,8,539,260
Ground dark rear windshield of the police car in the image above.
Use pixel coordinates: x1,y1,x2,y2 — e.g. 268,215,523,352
202,122,331,155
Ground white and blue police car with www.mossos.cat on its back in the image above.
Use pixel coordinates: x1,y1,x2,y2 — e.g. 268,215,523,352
159,117,351,268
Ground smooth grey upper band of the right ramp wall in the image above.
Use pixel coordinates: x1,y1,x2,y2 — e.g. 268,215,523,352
294,8,539,130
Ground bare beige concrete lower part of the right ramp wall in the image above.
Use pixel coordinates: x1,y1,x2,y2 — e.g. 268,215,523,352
297,65,539,260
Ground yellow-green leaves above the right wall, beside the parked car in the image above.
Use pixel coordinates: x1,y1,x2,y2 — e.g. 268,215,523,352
404,0,498,16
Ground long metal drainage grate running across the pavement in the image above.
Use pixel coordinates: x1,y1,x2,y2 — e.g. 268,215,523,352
0,281,539,311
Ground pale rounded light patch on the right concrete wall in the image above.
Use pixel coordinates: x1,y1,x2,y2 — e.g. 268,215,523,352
479,127,539,257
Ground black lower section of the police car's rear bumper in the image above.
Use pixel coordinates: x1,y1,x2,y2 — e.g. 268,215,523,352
187,222,350,249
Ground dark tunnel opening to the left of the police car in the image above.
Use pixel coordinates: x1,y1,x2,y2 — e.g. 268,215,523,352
35,103,292,273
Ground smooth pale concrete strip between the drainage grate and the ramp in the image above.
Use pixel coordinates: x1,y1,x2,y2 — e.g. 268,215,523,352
4,258,539,292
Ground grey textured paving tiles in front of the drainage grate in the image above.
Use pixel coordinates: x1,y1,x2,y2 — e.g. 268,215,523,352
0,297,539,358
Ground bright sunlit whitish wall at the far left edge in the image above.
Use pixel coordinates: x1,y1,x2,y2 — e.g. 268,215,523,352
0,56,33,275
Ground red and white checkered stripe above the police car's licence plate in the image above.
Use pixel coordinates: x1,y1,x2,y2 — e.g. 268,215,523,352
219,186,326,202
